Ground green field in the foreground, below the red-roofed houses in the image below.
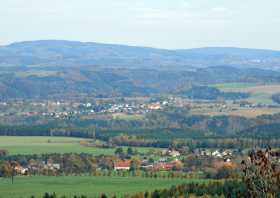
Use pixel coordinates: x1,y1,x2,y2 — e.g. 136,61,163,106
0,176,205,198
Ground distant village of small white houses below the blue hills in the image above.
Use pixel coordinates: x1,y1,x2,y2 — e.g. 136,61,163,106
0,97,172,119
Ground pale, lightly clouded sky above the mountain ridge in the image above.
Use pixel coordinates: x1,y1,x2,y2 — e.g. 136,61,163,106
0,0,280,50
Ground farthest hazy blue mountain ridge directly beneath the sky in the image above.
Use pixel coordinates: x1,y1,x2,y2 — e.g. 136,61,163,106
0,40,280,70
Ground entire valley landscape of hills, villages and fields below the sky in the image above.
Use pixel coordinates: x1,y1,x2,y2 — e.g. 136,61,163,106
0,41,280,198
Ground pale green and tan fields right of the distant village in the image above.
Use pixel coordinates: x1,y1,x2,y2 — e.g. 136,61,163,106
192,83,280,118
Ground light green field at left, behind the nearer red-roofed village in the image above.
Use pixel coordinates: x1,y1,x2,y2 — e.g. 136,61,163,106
0,136,155,155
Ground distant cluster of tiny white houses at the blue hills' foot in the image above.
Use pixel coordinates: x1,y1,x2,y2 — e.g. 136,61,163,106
0,100,170,119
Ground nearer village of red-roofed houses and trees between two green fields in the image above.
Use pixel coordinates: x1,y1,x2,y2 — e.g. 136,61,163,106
0,146,241,176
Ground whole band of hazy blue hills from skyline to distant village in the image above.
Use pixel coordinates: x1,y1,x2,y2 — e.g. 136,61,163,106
0,40,280,99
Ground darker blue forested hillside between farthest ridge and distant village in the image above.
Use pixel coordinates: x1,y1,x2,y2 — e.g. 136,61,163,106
0,66,280,99
